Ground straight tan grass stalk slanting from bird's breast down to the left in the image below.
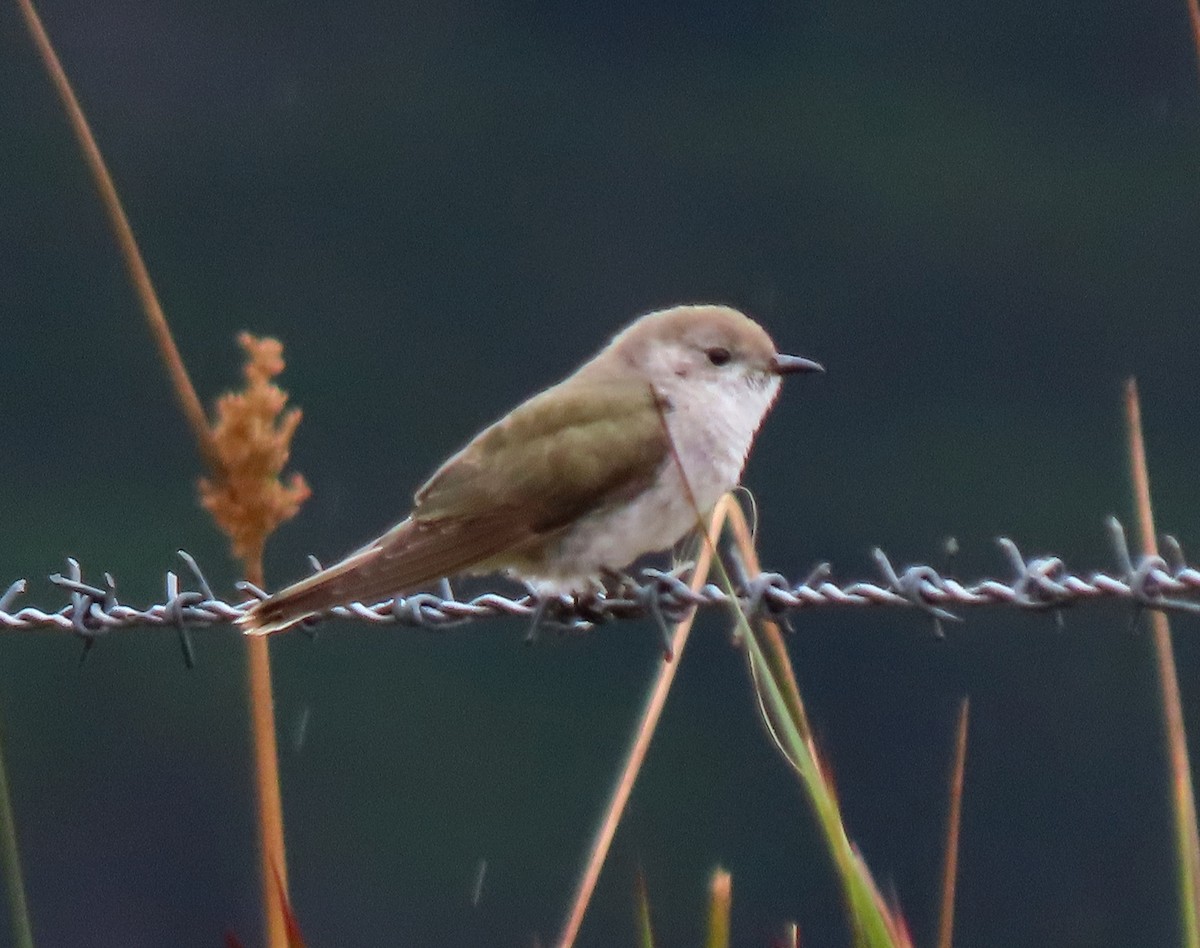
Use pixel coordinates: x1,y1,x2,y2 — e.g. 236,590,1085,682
556,496,737,948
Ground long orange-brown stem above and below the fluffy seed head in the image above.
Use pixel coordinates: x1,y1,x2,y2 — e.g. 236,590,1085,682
17,7,288,948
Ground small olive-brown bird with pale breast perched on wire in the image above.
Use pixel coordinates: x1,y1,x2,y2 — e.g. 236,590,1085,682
239,304,824,635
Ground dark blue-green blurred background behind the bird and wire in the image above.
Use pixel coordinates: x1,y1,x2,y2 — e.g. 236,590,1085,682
0,0,1200,948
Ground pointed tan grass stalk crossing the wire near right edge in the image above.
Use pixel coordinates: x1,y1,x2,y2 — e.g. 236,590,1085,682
1124,378,1200,948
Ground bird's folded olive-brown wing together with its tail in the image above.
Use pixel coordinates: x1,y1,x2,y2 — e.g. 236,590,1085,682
244,380,670,634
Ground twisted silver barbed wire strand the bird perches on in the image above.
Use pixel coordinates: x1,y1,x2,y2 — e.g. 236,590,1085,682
0,518,1200,665
